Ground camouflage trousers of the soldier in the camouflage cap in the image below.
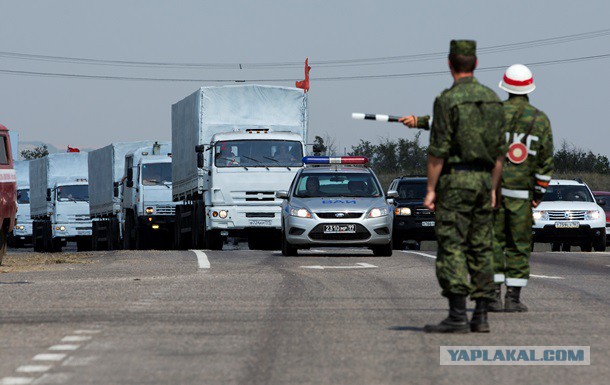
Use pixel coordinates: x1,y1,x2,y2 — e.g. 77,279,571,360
435,172,494,299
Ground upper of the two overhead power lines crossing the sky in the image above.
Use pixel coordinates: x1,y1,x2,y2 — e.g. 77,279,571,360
0,29,610,70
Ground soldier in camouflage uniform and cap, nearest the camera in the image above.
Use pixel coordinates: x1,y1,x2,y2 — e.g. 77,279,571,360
401,40,505,333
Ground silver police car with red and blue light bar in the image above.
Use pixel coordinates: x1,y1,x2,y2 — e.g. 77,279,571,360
276,156,398,256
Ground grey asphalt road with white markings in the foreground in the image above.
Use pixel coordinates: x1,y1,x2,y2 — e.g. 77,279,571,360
0,249,610,385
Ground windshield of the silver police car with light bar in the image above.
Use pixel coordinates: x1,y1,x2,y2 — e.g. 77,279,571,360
294,172,381,198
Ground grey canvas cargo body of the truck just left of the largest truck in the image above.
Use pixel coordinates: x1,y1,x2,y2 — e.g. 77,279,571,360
88,140,154,250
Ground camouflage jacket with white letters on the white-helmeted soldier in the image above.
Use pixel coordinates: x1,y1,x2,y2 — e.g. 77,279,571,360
502,95,553,200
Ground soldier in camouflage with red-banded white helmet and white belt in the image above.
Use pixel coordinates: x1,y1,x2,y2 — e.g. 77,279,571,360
489,64,553,312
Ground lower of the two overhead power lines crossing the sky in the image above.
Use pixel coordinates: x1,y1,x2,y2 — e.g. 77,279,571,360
0,53,610,83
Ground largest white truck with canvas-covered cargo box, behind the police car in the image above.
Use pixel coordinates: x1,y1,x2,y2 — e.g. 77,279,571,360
172,85,308,250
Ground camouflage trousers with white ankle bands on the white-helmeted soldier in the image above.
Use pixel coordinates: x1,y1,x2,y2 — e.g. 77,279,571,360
493,196,533,287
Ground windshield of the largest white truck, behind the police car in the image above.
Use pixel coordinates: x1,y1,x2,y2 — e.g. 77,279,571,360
214,140,303,167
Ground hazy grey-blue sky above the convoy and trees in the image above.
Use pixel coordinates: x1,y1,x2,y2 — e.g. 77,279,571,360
0,0,610,155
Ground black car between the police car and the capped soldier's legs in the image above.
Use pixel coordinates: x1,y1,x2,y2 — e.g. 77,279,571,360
390,176,436,250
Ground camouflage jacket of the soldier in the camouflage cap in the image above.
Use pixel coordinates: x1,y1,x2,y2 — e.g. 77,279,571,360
428,77,506,170
